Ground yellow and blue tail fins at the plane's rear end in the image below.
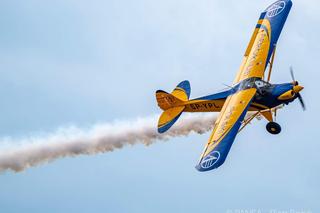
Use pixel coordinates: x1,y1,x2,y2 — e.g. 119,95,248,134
156,81,191,133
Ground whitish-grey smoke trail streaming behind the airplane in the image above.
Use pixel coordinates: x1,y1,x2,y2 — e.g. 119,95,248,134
0,113,216,172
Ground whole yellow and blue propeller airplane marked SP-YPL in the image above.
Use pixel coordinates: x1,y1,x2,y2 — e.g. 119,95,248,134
156,0,305,171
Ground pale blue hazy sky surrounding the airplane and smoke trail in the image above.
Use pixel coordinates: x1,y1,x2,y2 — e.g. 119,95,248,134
0,0,320,212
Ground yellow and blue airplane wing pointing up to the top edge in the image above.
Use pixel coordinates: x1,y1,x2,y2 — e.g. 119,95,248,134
233,0,292,84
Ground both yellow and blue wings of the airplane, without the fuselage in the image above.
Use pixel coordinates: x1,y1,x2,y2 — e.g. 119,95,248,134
196,0,292,171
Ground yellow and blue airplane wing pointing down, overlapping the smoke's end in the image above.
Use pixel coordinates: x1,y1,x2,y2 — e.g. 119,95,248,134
196,88,256,171
